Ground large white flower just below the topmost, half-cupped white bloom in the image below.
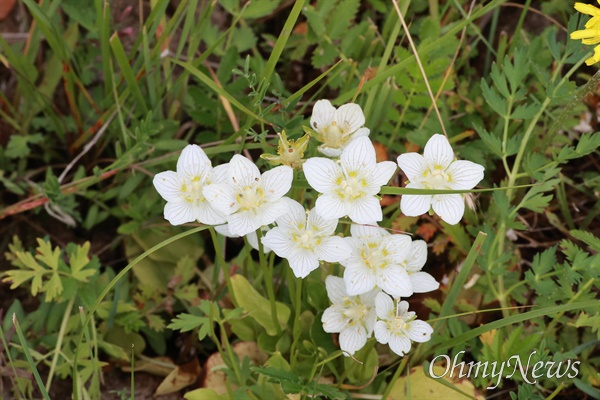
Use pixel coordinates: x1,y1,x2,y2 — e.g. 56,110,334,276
303,137,396,224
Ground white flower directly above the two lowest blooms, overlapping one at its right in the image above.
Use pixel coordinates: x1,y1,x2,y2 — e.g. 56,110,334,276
340,223,413,297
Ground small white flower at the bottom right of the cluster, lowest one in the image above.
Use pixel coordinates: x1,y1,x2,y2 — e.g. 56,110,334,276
375,293,433,356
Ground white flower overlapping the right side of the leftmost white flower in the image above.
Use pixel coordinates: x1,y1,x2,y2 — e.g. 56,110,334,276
204,154,294,236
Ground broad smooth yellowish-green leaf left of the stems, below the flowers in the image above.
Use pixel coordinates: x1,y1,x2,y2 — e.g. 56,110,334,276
231,274,291,336
